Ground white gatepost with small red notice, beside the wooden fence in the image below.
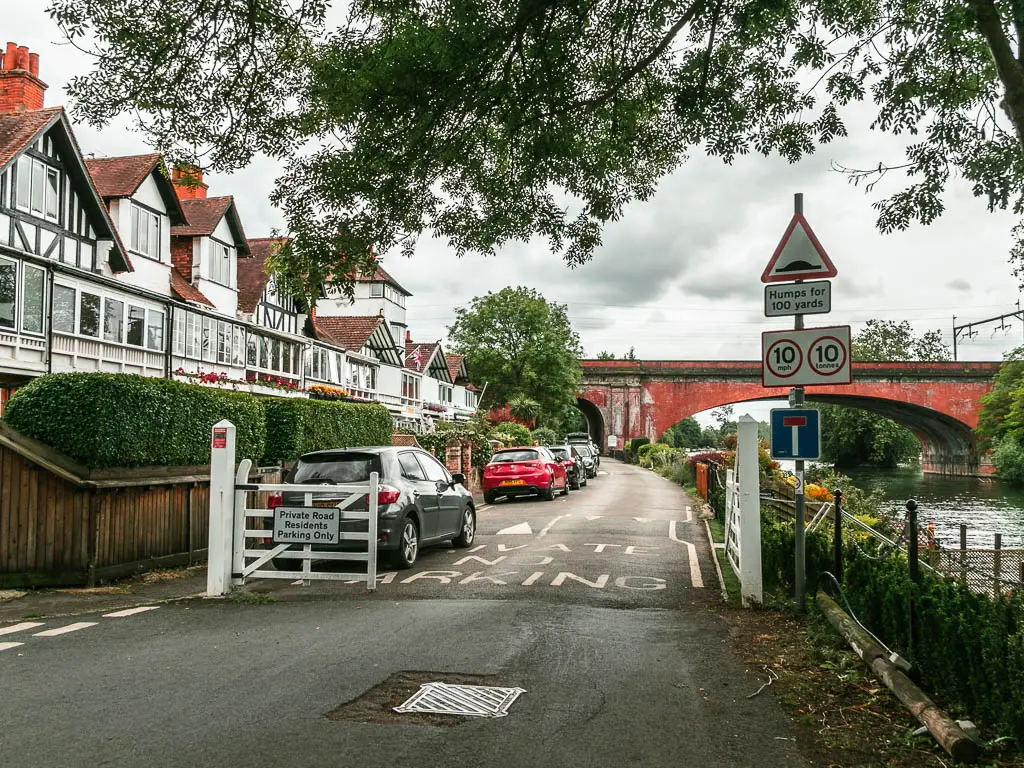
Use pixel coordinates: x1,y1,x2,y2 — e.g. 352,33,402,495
206,419,234,597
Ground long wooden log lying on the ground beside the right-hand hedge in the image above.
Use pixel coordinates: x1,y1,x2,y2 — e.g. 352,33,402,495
816,592,978,763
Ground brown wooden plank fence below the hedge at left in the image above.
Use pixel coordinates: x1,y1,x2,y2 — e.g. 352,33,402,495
0,423,281,587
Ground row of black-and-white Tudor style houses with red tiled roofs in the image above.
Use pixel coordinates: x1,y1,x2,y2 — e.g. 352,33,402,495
0,44,477,428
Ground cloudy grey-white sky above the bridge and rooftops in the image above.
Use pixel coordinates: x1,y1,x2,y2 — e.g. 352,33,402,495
8,0,1024,421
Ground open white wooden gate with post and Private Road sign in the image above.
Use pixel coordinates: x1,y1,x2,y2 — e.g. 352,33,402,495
207,421,379,595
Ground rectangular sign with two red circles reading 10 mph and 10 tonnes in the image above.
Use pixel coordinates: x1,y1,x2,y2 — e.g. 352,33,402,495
761,326,853,387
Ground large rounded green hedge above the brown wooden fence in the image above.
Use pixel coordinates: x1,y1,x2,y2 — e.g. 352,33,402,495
4,374,266,469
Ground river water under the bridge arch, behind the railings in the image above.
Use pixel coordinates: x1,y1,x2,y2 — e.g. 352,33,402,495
846,468,1024,549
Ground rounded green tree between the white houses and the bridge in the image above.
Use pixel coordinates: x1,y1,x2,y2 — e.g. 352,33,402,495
447,287,583,425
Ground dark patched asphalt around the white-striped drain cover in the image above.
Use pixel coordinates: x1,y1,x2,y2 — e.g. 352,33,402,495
325,672,505,728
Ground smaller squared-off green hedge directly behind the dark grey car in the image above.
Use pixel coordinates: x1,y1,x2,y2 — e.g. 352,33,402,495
264,397,391,464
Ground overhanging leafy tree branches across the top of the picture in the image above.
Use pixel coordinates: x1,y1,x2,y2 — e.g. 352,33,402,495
49,0,1024,286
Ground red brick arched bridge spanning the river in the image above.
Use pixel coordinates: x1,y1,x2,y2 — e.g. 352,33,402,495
578,360,999,474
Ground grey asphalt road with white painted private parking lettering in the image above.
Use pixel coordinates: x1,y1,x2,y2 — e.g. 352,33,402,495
0,460,807,768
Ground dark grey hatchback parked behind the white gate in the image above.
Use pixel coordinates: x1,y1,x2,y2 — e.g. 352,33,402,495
271,445,476,570
